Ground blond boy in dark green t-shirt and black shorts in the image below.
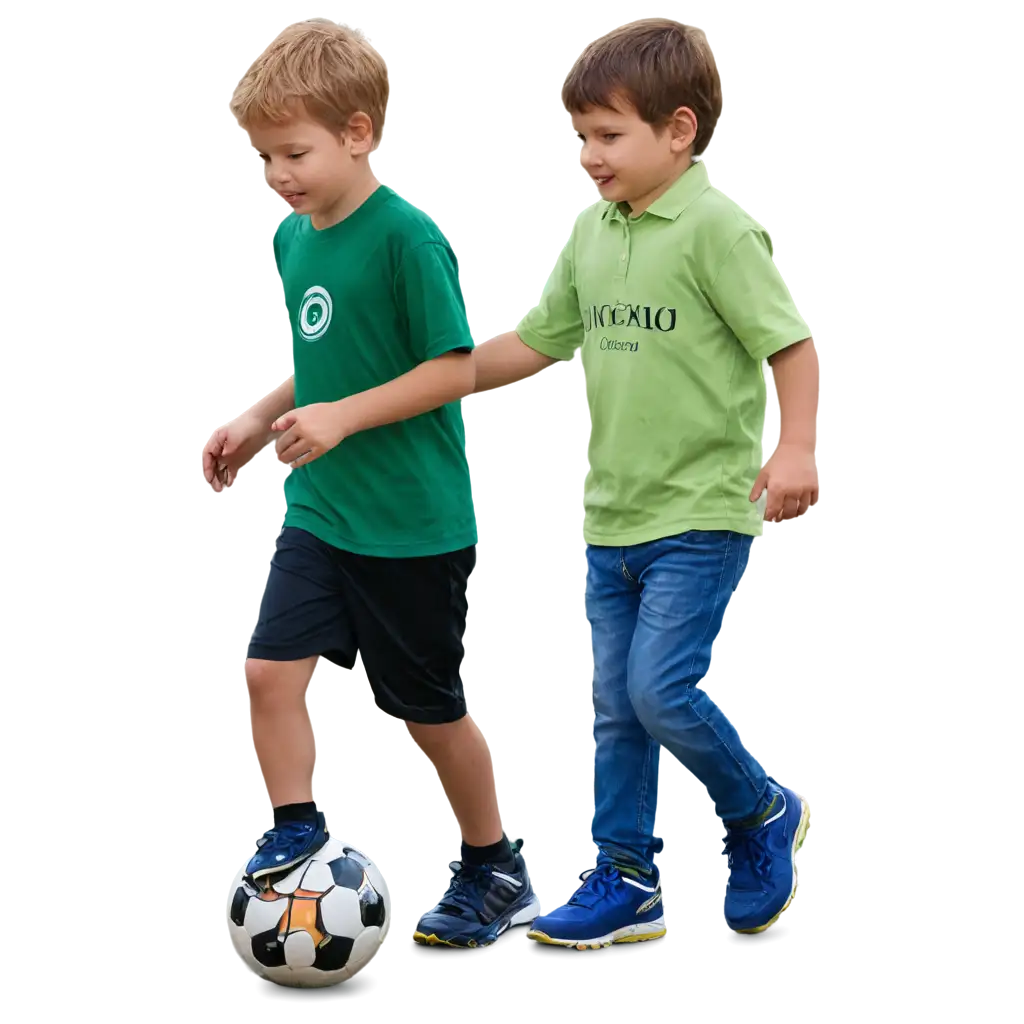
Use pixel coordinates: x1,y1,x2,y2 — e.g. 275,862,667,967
194,19,541,948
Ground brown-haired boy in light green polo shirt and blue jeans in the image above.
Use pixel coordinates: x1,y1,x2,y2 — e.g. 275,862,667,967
474,22,818,948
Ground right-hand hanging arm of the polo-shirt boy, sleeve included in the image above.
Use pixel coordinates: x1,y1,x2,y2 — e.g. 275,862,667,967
709,228,820,522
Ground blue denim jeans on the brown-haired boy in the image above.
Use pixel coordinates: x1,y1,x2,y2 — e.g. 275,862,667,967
584,531,769,869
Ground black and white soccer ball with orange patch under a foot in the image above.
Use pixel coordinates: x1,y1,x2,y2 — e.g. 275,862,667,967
224,833,391,988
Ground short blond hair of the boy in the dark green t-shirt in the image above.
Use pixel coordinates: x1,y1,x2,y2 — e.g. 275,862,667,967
224,17,391,139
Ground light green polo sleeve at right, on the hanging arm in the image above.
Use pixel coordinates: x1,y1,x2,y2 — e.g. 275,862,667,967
709,228,814,360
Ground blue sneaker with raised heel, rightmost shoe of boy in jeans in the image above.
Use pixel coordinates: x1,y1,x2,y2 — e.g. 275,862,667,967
725,785,814,935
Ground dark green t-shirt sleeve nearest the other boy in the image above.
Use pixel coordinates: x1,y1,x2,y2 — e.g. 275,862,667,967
395,242,474,361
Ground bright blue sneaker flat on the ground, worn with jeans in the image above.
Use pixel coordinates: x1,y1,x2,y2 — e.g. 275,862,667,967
526,864,669,950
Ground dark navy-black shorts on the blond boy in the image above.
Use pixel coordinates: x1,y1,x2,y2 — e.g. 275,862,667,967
246,526,476,725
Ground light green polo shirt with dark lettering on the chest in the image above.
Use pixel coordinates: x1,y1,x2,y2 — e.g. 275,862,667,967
514,161,813,547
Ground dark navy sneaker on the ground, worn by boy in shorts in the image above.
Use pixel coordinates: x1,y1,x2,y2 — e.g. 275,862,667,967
412,843,544,949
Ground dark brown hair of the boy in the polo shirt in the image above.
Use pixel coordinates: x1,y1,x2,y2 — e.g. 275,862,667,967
562,18,722,157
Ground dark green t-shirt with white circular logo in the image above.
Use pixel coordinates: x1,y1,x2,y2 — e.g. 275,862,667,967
272,185,477,557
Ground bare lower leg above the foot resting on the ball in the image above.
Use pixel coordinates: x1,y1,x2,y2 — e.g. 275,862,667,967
242,658,317,808
